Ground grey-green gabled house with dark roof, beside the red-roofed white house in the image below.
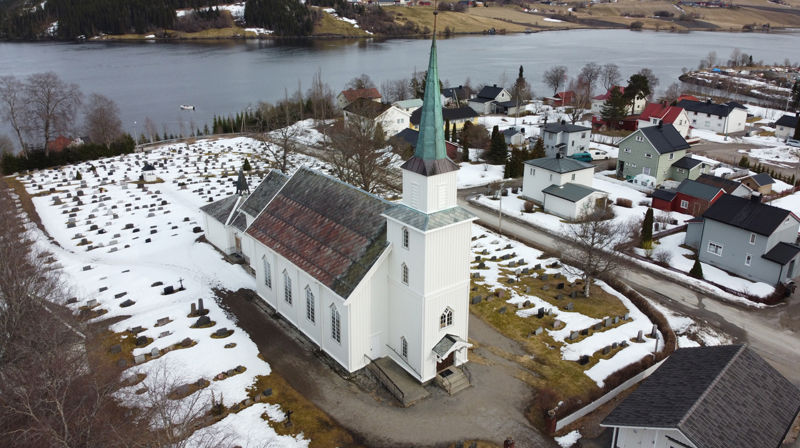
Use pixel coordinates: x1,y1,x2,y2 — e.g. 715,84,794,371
617,124,699,185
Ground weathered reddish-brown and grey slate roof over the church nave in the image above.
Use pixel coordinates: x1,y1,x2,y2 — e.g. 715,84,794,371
247,168,392,299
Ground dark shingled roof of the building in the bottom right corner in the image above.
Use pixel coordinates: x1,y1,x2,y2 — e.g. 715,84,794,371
602,345,800,448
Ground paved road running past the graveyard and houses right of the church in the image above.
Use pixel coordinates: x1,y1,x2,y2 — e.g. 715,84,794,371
459,187,800,385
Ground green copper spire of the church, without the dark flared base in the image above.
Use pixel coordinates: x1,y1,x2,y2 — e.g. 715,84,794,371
414,36,447,160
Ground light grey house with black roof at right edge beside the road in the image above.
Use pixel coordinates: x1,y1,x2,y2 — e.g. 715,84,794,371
684,194,800,285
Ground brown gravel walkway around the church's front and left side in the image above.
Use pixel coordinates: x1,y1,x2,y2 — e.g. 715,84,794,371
223,291,557,448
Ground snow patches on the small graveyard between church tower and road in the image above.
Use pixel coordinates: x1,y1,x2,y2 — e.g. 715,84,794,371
472,224,663,387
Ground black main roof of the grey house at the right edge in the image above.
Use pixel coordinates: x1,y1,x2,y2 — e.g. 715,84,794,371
703,194,791,236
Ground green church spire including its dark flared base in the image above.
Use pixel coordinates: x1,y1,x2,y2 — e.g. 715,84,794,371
401,37,458,176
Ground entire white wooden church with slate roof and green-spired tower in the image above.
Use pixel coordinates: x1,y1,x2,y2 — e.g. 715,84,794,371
202,39,476,383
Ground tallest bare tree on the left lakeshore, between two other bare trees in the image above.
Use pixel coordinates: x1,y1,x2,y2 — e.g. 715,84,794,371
25,72,82,155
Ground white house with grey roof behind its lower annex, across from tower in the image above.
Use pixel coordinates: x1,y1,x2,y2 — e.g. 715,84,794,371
522,154,594,204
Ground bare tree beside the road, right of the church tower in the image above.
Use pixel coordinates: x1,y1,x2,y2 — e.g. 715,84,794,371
562,206,624,297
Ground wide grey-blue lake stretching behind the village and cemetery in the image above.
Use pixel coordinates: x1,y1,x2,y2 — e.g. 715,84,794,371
0,30,800,137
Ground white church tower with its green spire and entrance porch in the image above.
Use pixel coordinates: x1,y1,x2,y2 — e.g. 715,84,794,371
384,27,477,383
